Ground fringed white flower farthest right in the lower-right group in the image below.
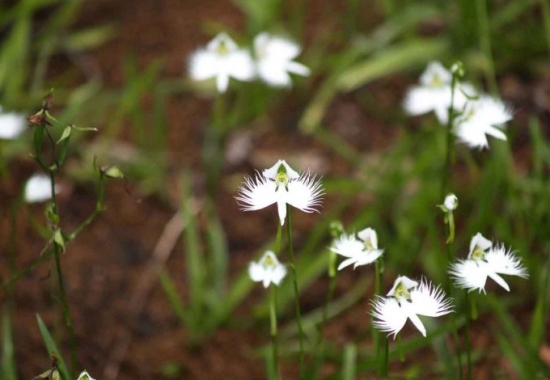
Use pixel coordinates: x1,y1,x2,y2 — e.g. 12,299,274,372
449,233,529,293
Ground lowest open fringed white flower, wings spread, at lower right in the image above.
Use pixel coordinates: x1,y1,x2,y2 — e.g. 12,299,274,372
372,276,453,339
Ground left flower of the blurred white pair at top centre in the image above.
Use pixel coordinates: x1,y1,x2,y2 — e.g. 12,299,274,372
189,33,254,92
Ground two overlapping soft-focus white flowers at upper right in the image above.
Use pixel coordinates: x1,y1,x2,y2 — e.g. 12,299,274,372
404,62,512,148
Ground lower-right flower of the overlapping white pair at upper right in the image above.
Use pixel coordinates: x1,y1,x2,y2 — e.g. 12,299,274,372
454,95,512,148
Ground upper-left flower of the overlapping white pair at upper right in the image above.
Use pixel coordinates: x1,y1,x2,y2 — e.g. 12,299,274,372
403,62,475,124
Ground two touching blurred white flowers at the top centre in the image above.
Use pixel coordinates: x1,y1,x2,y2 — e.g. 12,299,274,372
189,33,310,92
